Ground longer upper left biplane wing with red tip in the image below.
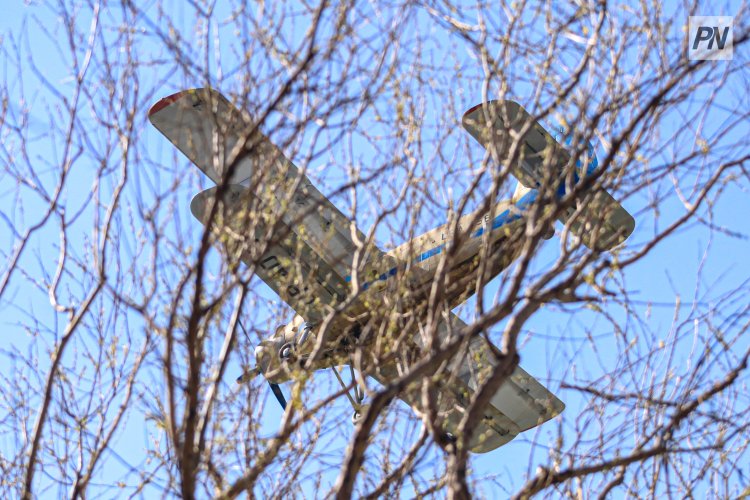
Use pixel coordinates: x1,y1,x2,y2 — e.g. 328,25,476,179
149,89,374,278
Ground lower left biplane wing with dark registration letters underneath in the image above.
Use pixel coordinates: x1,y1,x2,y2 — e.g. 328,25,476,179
190,184,347,322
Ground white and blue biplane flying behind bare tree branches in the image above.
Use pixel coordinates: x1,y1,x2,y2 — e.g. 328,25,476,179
148,88,635,453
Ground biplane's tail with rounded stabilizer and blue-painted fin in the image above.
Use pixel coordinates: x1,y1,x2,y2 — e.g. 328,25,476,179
462,101,635,250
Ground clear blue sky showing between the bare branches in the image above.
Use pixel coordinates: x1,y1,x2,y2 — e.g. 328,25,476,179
0,1,750,496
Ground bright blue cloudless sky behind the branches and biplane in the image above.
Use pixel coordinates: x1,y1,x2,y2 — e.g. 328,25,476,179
0,1,750,496
